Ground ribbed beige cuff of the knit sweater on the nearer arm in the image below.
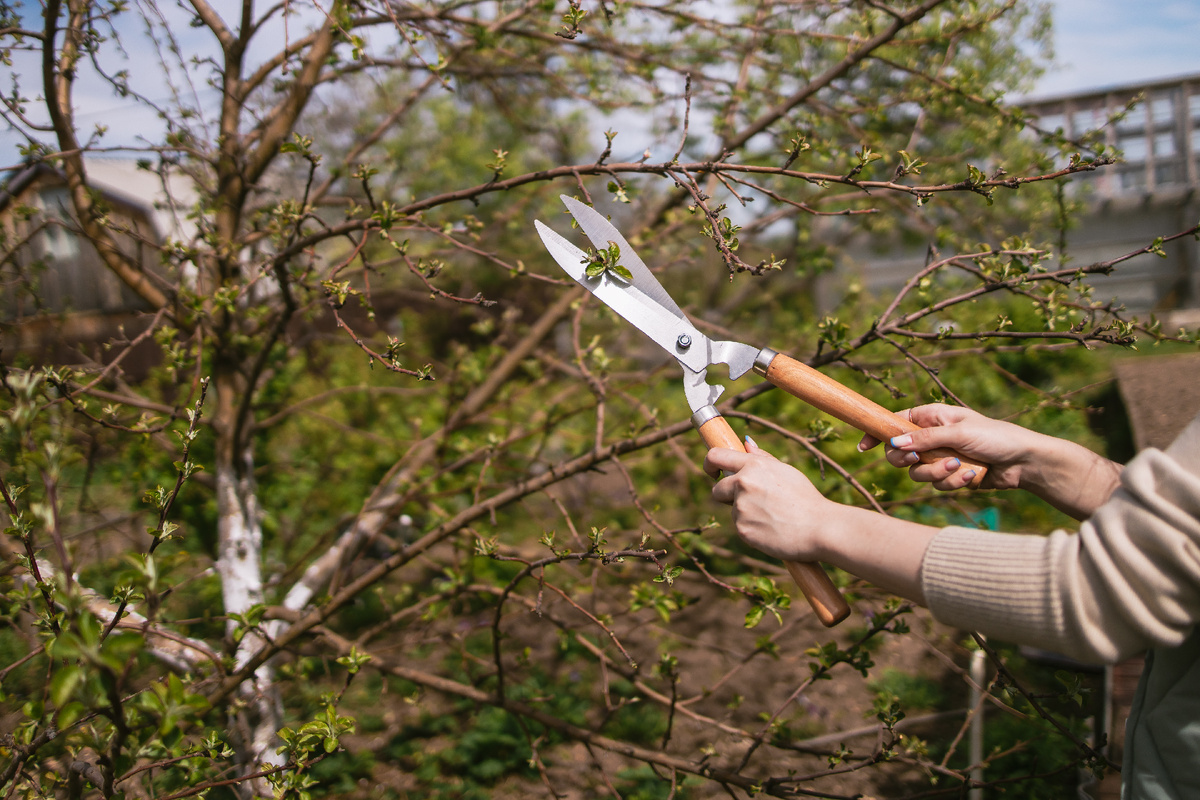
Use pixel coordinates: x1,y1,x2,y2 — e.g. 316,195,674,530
920,528,1063,651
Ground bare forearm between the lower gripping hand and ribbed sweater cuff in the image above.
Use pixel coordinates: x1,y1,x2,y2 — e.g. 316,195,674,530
818,505,938,606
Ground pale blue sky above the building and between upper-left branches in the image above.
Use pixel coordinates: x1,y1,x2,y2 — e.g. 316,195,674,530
0,0,1200,169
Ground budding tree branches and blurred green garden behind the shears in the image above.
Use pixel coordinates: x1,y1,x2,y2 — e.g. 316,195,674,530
0,1,1194,800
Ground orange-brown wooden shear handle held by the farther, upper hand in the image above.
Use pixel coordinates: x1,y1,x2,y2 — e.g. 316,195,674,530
760,350,988,488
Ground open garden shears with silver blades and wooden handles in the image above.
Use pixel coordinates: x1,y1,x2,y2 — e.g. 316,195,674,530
534,196,985,626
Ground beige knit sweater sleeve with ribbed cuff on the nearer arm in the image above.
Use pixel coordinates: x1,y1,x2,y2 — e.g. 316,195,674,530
920,416,1200,662
